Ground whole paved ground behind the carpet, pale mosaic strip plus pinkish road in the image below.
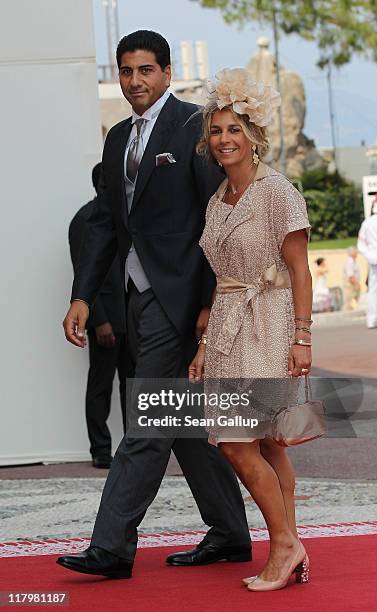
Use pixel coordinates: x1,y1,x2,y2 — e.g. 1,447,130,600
0,312,377,541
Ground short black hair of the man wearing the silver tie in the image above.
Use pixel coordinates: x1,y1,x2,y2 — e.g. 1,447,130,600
117,30,171,70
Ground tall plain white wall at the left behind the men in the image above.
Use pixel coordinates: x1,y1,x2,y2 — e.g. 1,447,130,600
0,0,121,465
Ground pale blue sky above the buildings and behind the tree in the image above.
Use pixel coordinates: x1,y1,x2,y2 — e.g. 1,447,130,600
92,0,377,147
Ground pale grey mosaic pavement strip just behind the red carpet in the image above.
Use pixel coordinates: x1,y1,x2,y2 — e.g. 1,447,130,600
0,476,377,541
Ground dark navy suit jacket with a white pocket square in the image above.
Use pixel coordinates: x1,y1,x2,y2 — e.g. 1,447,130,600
72,95,223,333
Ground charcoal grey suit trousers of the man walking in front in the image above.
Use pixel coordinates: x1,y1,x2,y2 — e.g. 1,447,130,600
92,283,250,561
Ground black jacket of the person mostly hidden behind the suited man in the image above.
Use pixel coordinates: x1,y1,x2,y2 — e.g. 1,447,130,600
68,198,126,334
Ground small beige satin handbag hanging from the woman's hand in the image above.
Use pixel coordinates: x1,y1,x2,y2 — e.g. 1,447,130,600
271,376,326,446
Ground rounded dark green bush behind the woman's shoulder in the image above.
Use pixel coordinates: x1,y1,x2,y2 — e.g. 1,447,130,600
300,169,364,240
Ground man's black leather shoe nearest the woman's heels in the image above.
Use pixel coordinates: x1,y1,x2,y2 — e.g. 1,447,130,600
166,542,251,565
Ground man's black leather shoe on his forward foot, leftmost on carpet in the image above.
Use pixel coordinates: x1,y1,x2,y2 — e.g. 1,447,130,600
56,546,133,578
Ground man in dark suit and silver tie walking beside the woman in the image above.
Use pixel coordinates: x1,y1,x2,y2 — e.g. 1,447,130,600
58,30,251,578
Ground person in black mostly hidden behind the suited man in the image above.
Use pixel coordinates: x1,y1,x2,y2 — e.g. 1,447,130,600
68,164,126,469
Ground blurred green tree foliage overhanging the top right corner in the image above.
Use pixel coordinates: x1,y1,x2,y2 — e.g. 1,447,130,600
194,0,377,68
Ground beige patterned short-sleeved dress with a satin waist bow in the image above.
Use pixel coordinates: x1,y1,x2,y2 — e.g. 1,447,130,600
200,163,310,442
